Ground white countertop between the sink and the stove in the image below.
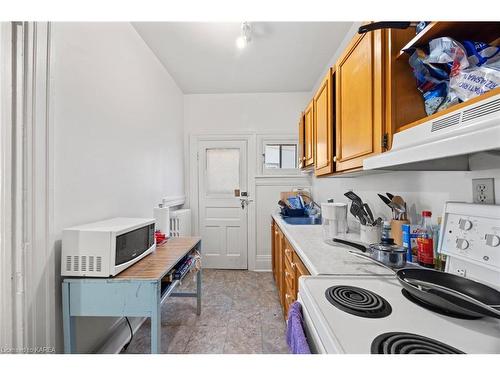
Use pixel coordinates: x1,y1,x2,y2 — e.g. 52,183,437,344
272,214,394,276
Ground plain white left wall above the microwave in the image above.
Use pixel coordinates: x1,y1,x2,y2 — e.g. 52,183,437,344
51,23,184,352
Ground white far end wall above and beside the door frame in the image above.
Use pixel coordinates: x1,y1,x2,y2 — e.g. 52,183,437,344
184,92,311,270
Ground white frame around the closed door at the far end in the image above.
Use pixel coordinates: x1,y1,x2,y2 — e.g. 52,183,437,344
187,132,257,270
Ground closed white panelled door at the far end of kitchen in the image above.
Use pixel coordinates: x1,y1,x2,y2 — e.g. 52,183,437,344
198,140,250,269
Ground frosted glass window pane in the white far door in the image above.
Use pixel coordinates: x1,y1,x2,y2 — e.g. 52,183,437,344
206,148,240,195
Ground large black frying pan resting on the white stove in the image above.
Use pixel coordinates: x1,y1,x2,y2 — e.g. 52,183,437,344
350,251,500,319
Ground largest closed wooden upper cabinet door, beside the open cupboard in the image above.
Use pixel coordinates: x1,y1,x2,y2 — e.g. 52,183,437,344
335,30,385,172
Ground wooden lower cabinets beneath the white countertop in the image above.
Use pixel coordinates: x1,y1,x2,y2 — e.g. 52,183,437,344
271,220,310,319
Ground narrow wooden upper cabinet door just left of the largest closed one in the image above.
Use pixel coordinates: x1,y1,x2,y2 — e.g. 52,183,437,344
313,69,334,176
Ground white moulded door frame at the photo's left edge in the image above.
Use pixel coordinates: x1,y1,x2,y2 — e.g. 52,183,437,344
0,22,55,350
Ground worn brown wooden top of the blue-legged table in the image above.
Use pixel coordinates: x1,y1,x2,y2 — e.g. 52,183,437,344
113,237,201,280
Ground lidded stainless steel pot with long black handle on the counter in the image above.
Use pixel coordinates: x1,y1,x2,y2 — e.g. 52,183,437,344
333,238,406,268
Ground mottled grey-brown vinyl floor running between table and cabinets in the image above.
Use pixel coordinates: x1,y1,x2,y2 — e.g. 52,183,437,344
125,269,288,354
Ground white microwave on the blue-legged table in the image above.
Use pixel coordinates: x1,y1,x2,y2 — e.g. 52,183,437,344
61,217,156,277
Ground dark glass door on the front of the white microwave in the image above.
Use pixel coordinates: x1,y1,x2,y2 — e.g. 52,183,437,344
115,224,155,266
